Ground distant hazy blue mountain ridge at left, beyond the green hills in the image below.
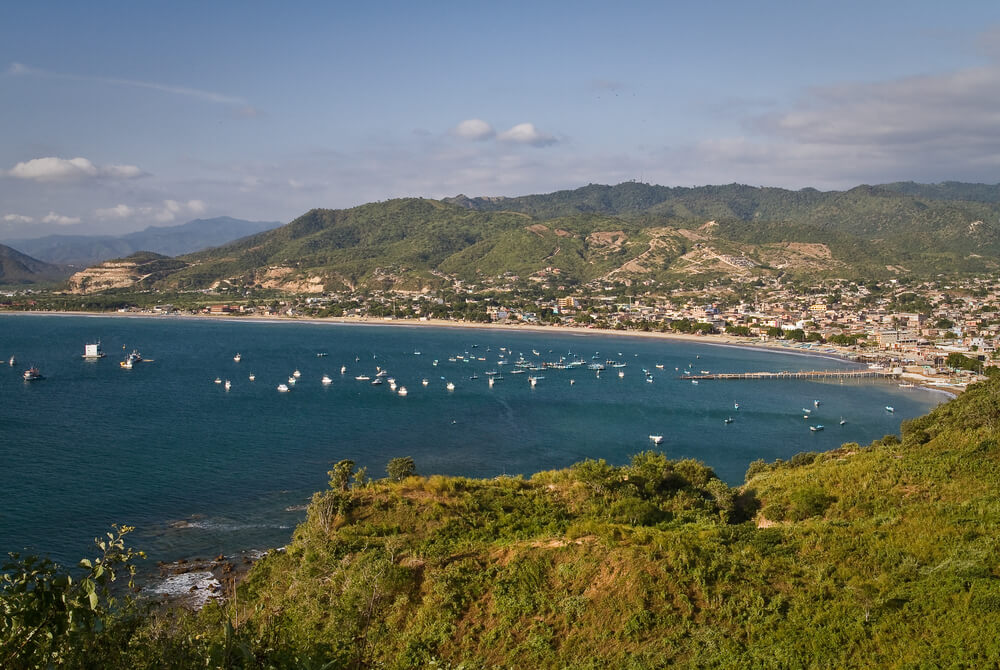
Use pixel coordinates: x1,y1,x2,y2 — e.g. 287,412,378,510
5,216,281,266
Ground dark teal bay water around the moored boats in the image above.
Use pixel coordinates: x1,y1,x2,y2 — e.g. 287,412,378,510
0,315,943,562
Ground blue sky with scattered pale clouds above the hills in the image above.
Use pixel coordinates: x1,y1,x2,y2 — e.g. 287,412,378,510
0,0,1000,239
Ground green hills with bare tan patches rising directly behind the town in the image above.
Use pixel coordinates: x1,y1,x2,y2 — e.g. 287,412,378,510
58,182,1000,292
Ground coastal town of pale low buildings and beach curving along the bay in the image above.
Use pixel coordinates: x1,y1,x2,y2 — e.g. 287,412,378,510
0,274,1000,393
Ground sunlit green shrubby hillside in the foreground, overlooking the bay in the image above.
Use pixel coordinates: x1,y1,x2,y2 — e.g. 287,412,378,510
0,379,1000,668
